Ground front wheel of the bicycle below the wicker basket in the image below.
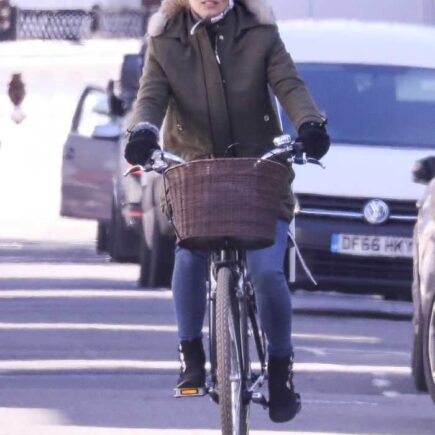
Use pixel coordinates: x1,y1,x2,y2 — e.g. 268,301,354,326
216,267,249,435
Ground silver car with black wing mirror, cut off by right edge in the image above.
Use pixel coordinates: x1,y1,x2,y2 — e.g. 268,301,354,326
412,156,435,402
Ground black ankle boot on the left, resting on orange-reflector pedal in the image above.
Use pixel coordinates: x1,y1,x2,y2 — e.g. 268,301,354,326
175,338,205,388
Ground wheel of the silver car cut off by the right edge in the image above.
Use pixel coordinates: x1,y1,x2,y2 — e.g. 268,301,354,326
423,294,435,402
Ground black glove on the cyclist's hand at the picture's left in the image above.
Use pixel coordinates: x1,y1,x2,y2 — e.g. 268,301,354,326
124,128,160,166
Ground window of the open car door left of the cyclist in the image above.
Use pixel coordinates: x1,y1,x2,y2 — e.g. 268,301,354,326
77,90,110,137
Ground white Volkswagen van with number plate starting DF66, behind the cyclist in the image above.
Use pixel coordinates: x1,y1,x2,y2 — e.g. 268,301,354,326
279,21,435,297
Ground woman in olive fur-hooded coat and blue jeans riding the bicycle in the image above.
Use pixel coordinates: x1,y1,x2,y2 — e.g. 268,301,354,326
125,0,329,422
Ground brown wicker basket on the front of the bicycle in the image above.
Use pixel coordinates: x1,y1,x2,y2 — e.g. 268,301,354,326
165,158,289,249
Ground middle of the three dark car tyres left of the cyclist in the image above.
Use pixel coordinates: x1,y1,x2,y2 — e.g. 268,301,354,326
109,199,137,263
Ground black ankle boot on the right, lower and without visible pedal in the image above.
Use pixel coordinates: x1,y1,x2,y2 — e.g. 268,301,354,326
268,356,301,423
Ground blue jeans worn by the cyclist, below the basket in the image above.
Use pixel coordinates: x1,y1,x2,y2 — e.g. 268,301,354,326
172,220,292,357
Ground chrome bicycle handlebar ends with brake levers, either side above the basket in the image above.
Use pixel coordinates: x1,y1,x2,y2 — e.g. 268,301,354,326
124,134,325,177
